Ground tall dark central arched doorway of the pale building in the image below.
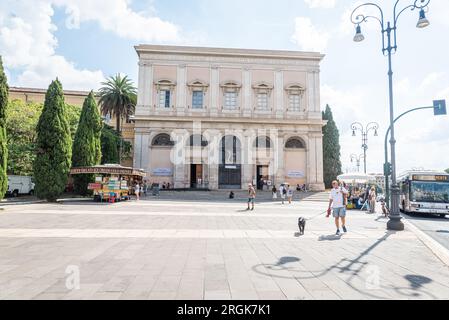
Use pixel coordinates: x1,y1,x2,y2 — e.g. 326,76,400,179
218,136,242,189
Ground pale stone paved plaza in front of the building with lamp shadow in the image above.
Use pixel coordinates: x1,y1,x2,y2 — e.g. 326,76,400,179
0,192,449,300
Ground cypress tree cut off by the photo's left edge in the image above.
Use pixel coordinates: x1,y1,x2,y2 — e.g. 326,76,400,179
0,56,9,199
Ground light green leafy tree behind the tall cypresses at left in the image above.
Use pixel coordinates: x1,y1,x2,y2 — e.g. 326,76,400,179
6,100,81,176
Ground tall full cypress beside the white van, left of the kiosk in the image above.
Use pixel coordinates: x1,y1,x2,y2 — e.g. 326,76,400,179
34,79,72,202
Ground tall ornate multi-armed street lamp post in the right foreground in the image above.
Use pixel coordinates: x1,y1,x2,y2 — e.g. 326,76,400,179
351,0,430,231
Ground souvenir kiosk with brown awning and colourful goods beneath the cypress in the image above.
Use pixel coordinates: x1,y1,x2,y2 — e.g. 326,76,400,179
70,164,146,203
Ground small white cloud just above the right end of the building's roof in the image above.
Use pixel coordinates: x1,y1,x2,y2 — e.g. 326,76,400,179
292,17,330,52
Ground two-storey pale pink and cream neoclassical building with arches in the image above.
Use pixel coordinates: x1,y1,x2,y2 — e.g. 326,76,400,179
134,45,324,190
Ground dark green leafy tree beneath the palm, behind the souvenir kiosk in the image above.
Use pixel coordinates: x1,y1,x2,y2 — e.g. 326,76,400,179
101,124,132,164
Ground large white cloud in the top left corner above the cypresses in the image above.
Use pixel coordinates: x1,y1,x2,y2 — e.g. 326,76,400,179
0,0,104,90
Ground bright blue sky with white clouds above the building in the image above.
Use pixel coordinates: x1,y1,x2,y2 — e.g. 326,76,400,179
0,0,449,173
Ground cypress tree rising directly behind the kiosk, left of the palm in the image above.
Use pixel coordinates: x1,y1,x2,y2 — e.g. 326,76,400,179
72,92,102,195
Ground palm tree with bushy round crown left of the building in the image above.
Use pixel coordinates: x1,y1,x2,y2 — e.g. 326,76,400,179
99,74,137,160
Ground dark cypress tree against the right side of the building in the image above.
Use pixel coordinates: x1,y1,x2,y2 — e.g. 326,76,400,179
322,105,342,188
